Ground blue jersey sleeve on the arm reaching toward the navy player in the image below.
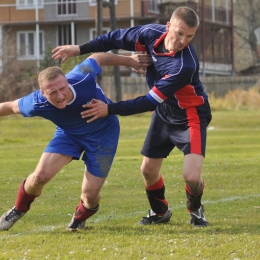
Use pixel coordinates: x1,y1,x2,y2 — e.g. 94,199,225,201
66,58,102,82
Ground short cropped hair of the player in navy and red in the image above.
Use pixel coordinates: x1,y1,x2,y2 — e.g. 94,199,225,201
171,6,200,28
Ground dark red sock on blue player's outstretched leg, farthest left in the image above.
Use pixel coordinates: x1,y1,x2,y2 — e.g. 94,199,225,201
15,179,37,212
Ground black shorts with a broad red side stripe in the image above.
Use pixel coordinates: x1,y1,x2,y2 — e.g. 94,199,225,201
141,101,211,158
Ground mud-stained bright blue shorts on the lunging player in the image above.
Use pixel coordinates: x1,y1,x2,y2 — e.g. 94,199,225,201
44,117,120,178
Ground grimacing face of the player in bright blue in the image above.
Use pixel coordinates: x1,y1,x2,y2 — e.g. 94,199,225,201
41,75,73,109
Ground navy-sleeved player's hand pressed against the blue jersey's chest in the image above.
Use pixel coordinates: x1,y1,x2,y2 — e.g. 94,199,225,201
81,98,108,123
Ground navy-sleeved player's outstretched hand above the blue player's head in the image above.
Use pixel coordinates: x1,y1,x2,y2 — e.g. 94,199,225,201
52,45,80,63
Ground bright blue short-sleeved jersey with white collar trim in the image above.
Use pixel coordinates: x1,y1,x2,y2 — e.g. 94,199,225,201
18,59,117,136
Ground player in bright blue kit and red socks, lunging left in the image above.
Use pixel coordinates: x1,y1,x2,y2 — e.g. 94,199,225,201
0,53,151,231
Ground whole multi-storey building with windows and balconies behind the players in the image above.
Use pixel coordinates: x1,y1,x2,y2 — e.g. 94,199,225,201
0,0,260,76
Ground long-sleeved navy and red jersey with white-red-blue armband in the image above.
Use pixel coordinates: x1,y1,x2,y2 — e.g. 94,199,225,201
90,24,208,115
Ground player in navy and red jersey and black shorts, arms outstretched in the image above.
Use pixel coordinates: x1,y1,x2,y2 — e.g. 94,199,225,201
53,7,211,227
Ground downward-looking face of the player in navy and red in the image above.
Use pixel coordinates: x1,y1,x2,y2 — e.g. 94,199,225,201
165,18,197,52
